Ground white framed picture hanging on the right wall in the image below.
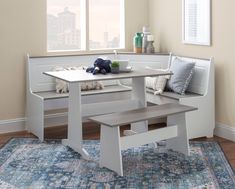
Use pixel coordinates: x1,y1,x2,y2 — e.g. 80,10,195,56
183,0,211,45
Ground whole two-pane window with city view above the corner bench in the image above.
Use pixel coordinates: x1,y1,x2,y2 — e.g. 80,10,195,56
47,0,124,51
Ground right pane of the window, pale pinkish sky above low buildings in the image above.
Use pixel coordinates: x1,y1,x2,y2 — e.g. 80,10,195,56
89,0,121,49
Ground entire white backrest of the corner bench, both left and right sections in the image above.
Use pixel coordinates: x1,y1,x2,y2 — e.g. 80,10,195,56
27,53,214,95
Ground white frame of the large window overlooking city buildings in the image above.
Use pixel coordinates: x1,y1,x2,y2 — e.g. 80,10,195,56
47,0,126,53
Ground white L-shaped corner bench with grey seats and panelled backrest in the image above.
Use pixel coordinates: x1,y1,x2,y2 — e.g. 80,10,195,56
26,53,214,140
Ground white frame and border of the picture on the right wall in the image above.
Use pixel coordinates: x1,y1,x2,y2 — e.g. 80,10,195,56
182,0,211,46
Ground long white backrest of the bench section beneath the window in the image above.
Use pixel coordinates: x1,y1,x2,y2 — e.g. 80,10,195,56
27,54,169,92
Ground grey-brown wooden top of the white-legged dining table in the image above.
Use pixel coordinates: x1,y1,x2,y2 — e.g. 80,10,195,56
44,68,172,83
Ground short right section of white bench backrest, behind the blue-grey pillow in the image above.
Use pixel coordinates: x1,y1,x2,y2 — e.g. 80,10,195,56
171,56,214,95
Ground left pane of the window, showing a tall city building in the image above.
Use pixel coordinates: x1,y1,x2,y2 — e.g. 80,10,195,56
47,0,81,51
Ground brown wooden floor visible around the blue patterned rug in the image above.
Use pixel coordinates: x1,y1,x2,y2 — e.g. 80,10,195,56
0,123,235,170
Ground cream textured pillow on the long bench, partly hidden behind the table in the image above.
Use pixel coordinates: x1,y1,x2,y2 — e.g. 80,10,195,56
53,66,104,93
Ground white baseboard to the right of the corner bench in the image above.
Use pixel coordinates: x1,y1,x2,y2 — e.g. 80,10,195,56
214,122,235,142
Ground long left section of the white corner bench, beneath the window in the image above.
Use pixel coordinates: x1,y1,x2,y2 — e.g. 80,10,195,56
26,54,168,140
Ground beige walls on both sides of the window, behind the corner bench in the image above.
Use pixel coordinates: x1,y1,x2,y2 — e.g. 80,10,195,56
0,0,235,126
